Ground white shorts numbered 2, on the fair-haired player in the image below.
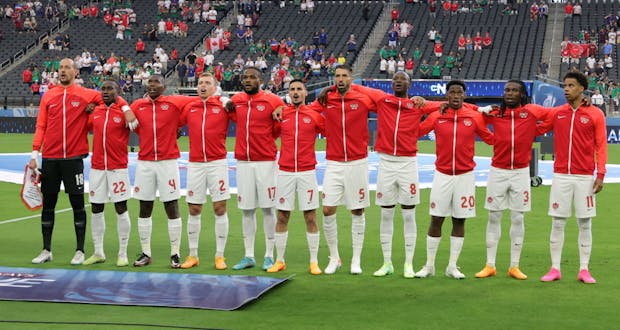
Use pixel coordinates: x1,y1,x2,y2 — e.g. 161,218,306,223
185,159,230,204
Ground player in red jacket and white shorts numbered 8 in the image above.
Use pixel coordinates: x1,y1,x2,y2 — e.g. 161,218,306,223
352,71,443,278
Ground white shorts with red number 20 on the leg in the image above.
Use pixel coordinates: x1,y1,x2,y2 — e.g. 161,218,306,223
429,171,476,219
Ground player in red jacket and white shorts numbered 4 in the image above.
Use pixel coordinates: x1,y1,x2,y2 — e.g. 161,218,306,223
131,74,191,268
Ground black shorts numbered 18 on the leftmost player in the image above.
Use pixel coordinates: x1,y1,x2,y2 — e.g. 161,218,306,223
41,158,84,195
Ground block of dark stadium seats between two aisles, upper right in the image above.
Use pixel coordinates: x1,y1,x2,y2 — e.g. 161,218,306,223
365,4,546,79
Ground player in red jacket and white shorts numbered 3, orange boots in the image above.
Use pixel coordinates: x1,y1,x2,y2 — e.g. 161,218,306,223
476,80,550,280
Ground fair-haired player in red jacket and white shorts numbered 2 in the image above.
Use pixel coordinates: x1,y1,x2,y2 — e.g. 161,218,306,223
181,73,230,270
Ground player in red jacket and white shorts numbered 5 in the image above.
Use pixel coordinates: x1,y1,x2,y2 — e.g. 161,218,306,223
310,64,376,274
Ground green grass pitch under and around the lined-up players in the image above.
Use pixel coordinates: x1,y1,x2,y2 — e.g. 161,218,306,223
0,134,620,329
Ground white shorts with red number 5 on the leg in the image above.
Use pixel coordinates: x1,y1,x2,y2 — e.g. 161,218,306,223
323,158,370,210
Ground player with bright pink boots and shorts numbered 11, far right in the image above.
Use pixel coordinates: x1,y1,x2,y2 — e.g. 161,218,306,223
541,71,607,284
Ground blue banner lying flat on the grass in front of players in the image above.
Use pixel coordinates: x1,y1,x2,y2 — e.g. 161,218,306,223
0,267,287,310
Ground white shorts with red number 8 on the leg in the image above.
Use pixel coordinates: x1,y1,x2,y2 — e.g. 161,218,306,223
375,153,420,206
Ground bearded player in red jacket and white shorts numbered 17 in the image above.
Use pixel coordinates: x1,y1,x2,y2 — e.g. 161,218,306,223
227,67,285,270
